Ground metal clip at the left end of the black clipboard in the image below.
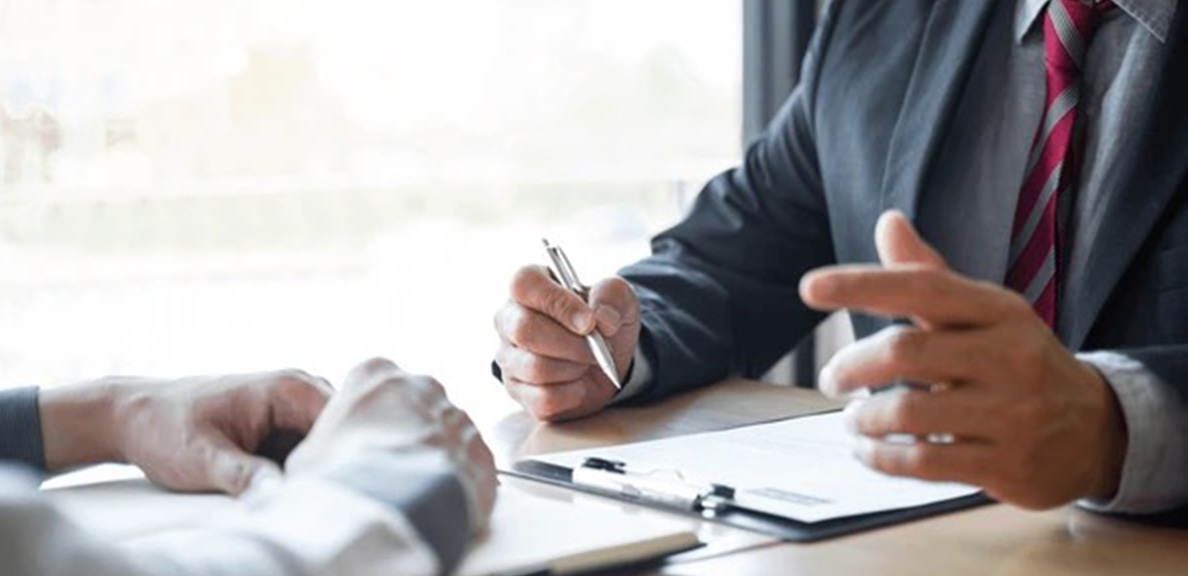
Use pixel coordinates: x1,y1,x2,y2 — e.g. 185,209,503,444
573,457,734,517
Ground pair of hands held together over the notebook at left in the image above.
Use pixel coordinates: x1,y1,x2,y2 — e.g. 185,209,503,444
40,359,497,524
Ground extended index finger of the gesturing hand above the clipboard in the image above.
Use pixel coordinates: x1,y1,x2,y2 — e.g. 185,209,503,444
801,265,1030,327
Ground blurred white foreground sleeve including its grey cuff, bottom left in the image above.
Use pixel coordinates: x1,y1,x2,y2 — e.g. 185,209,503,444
0,454,470,576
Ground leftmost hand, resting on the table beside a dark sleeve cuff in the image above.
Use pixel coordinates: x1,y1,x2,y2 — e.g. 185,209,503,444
40,371,331,494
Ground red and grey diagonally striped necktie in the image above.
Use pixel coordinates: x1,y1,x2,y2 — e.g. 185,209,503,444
1006,0,1113,327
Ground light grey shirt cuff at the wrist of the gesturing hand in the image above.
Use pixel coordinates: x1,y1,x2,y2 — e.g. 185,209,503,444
1076,352,1188,514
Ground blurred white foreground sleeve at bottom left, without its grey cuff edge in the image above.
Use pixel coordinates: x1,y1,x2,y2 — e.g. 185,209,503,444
0,463,441,576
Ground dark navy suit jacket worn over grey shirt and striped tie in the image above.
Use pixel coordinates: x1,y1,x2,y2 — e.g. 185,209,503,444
623,0,1188,400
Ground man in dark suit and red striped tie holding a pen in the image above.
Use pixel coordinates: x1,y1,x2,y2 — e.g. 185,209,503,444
495,0,1188,513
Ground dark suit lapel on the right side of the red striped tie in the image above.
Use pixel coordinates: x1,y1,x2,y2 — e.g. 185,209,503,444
1061,6,1188,350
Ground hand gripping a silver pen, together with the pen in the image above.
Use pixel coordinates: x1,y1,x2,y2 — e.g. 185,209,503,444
495,241,639,422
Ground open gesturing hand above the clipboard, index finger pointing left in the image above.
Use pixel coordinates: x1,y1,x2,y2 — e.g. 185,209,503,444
801,213,1126,508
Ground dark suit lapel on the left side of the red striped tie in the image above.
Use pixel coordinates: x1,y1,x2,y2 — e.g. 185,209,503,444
879,0,996,219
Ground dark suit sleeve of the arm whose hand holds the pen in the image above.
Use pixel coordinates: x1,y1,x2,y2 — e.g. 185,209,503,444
620,2,841,401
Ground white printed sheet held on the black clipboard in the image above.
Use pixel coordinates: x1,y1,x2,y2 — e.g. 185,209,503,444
533,412,978,523
